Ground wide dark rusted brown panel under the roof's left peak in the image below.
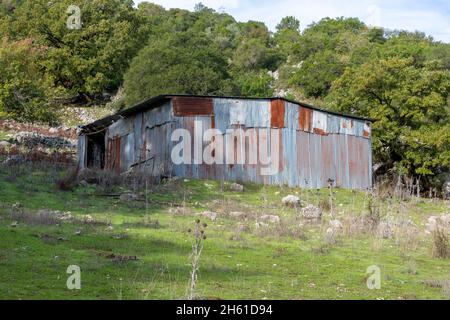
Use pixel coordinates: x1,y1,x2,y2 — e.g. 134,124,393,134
172,97,214,117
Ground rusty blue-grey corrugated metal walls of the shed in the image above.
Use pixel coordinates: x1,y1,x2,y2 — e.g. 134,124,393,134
80,97,372,189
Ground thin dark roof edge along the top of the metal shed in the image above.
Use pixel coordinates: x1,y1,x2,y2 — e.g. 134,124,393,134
80,94,376,134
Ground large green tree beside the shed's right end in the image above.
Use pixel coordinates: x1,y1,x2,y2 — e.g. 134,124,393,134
328,57,450,175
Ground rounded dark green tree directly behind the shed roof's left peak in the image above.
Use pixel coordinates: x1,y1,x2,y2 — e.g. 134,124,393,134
124,31,232,105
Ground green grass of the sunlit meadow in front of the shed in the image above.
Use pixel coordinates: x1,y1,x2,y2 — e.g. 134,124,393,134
0,167,450,299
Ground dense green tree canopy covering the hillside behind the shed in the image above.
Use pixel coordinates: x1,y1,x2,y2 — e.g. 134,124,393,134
0,0,450,182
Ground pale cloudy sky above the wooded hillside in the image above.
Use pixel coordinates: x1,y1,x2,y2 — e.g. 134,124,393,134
134,0,450,43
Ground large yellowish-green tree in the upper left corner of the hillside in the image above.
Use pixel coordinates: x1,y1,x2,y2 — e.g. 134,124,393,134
3,0,145,98
